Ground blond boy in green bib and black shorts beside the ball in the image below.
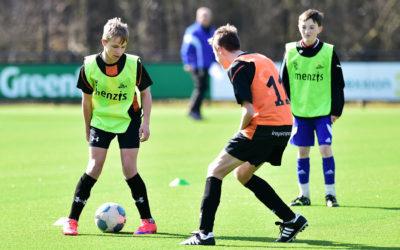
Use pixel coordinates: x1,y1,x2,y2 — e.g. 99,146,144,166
63,18,157,235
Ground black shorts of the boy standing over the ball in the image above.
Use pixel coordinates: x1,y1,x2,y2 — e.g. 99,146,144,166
89,118,141,149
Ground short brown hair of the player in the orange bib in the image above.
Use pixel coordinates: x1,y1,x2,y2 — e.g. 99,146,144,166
208,23,240,51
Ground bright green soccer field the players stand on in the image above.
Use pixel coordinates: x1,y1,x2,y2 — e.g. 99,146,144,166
0,103,400,249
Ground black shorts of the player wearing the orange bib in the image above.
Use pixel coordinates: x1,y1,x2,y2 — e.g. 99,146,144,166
225,125,292,166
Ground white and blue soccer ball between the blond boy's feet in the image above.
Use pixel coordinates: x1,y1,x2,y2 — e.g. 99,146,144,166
94,202,126,233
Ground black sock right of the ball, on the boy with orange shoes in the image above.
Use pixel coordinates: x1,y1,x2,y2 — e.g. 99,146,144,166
126,173,152,219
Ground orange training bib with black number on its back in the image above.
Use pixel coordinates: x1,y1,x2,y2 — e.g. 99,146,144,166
231,53,293,139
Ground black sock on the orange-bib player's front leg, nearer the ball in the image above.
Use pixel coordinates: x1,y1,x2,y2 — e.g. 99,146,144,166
200,177,222,235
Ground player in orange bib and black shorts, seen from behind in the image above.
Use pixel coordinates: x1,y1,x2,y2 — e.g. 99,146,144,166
181,24,307,245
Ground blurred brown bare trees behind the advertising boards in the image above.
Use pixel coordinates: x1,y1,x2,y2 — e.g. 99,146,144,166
0,0,400,63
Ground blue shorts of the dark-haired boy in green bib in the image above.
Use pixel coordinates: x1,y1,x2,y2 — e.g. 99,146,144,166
290,116,332,147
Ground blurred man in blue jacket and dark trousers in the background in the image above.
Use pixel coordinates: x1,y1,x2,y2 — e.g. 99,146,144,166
181,7,215,120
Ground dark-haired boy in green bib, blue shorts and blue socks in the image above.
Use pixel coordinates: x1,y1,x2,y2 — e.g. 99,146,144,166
281,9,344,207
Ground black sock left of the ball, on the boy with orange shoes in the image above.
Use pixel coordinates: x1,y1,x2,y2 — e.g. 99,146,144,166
69,173,97,221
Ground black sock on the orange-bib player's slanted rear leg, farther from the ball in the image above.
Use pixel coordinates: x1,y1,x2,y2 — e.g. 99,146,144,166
244,175,296,221
